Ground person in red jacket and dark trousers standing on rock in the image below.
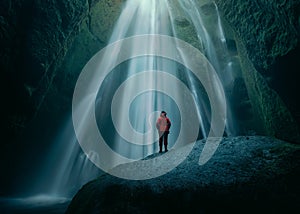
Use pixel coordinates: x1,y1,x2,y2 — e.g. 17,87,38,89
156,111,171,153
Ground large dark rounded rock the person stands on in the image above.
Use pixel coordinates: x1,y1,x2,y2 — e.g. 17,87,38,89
67,136,300,213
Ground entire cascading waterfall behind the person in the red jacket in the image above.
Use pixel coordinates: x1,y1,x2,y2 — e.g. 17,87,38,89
15,0,241,201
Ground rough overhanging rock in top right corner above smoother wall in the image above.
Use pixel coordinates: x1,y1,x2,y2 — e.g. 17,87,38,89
216,0,300,72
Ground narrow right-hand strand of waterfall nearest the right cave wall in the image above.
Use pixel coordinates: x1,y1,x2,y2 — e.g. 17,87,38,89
178,0,237,135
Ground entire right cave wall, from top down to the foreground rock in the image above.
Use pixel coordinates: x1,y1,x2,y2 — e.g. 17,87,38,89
216,0,300,142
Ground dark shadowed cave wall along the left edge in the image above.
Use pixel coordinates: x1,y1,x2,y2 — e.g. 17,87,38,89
0,0,88,195
